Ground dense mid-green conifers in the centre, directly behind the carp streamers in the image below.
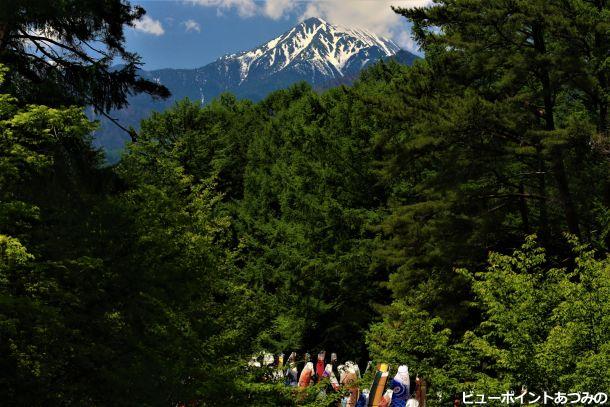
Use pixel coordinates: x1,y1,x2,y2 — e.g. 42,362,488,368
120,85,390,358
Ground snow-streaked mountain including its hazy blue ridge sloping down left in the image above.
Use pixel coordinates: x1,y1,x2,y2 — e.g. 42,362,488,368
96,18,417,159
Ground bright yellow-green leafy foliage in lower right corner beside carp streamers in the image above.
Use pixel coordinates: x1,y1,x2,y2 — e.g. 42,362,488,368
368,236,610,405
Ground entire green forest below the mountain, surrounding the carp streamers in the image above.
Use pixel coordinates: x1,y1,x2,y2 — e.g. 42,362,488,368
0,0,610,406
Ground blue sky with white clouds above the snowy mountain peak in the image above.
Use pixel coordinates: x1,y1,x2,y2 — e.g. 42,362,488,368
126,0,427,70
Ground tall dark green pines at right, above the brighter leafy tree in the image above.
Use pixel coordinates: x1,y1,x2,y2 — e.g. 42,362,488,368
368,1,608,342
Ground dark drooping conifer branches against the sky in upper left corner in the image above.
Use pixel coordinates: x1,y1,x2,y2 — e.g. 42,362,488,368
0,0,169,136
